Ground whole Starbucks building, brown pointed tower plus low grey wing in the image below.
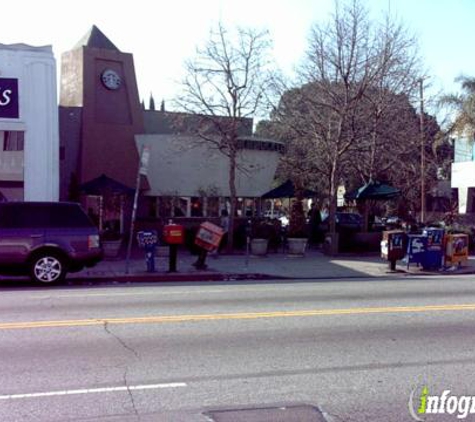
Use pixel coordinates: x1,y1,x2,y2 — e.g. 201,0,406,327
59,26,283,224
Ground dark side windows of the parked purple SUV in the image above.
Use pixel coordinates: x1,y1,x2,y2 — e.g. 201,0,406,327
0,202,92,229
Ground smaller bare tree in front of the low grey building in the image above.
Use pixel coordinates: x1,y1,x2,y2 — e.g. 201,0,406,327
178,24,271,249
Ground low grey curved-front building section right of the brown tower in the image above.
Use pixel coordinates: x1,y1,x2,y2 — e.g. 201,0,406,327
136,110,283,217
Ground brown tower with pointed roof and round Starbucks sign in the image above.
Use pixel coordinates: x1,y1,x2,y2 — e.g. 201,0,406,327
60,26,144,190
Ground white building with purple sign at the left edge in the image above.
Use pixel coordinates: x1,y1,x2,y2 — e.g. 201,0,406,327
0,44,59,201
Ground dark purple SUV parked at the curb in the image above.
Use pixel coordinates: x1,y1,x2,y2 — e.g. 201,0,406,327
0,202,102,283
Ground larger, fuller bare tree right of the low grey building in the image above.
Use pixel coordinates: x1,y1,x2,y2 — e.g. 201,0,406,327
274,0,419,232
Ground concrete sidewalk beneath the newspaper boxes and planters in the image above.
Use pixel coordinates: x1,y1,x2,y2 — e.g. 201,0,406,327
68,250,475,281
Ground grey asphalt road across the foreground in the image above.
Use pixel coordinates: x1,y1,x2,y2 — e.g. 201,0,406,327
0,276,475,422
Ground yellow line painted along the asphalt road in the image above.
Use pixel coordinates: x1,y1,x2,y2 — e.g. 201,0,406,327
0,304,475,330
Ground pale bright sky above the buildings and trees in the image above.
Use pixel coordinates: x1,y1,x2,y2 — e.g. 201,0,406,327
0,0,475,113
